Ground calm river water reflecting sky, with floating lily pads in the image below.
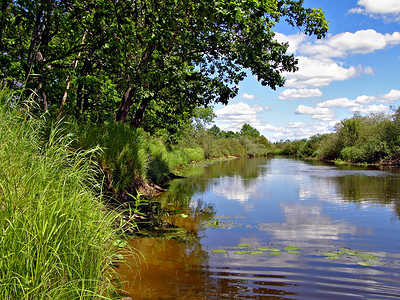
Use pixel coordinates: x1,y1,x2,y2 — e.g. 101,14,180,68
120,158,400,299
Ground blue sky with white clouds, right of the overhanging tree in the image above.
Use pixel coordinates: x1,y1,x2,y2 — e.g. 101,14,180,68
214,0,400,141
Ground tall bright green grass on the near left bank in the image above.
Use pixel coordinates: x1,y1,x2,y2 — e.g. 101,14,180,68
0,89,120,300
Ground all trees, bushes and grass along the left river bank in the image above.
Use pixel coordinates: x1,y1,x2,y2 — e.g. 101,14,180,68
0,0,328,299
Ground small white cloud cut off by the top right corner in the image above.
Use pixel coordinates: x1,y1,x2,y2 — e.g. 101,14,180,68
349,0,400,21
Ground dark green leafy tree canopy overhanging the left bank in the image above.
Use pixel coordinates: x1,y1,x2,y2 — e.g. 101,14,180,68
0,0,328,136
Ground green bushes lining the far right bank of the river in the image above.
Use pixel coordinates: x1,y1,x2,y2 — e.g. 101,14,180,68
274,109,400,165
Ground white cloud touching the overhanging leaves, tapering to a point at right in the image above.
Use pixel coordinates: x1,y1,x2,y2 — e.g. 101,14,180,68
284,56,366,88
